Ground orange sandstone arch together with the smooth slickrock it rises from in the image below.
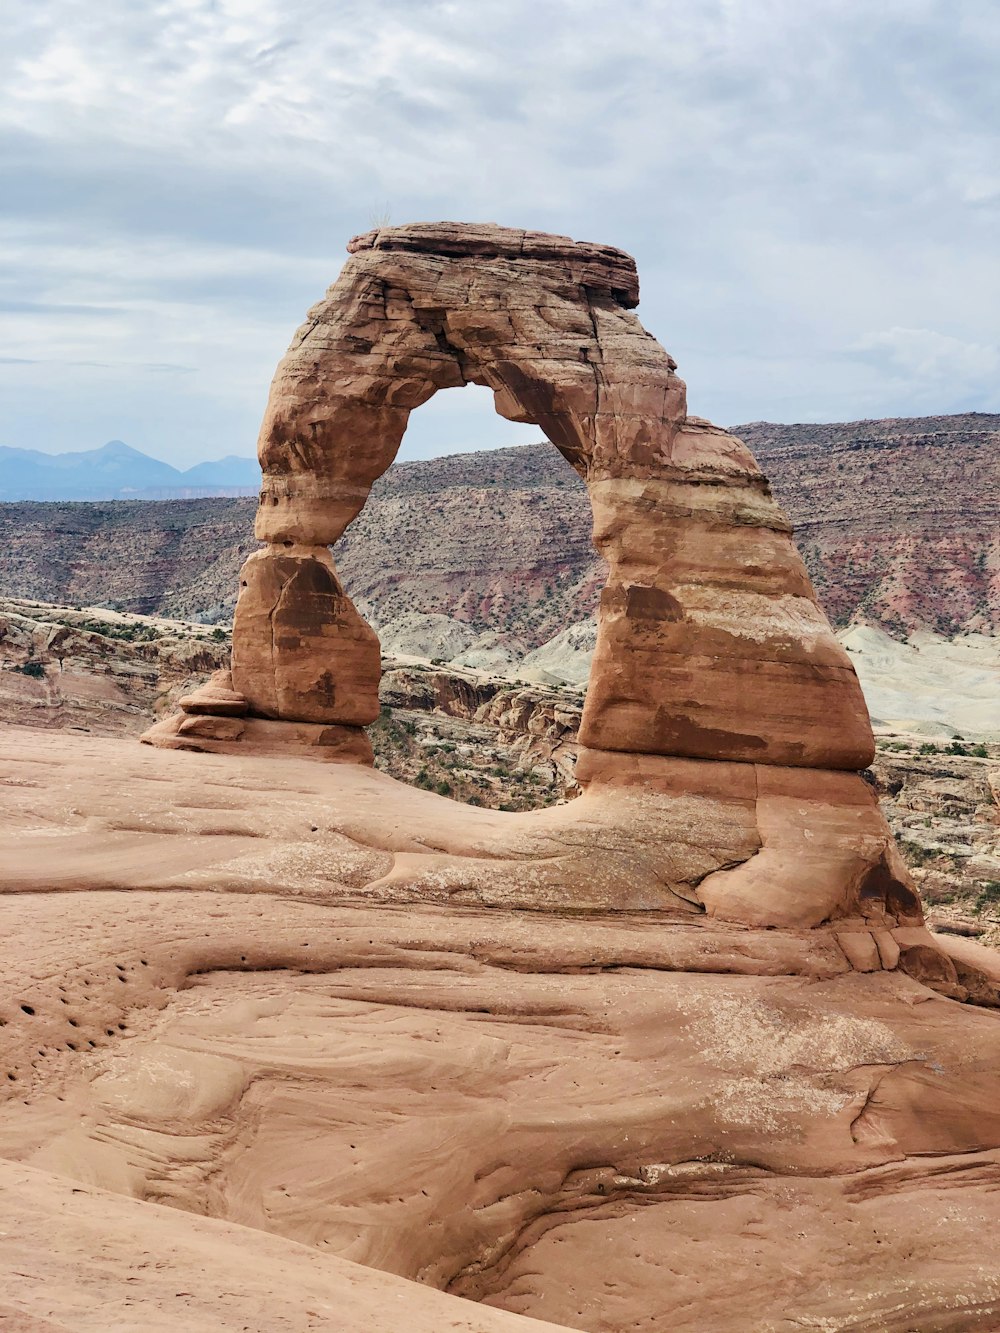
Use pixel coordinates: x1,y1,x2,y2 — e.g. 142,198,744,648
0,224,1000,1333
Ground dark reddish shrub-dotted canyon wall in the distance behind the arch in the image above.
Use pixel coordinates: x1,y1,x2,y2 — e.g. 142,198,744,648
0,413,1000,647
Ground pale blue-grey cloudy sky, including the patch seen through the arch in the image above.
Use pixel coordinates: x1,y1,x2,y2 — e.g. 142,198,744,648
0,0,1000,467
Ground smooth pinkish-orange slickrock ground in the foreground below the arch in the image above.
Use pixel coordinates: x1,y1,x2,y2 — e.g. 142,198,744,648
0,728,1000,1333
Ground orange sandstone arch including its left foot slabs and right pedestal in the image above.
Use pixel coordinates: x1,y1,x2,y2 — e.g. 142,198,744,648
145,223,906,927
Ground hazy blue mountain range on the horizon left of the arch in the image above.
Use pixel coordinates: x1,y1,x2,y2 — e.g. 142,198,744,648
0,440,260,500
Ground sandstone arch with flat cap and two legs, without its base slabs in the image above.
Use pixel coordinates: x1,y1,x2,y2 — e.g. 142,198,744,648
216,224,873,769
